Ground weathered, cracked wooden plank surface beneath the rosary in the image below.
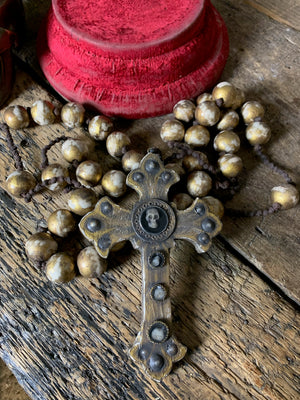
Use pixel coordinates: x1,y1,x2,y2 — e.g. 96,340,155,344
0,0,300,400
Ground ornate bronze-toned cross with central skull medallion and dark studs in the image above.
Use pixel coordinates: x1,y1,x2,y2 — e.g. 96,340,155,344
79,152,222,381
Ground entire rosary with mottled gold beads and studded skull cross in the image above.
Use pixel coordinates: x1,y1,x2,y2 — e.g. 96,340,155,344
0,82,299,381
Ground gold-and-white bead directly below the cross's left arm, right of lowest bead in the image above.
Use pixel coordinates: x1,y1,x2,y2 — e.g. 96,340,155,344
77,246,107,278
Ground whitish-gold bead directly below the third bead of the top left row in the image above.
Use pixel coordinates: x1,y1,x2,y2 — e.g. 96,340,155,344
61,139,94,162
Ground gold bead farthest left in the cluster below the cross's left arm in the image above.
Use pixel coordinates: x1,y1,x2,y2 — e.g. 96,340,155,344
25,232,58,262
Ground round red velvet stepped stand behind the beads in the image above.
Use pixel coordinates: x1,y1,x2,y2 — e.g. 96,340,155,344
38,0,229,118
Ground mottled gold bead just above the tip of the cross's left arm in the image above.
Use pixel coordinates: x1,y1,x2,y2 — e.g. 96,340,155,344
68,188,97,216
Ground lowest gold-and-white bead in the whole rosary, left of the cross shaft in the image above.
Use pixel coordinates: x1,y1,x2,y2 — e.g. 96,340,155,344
46,253,75,283
